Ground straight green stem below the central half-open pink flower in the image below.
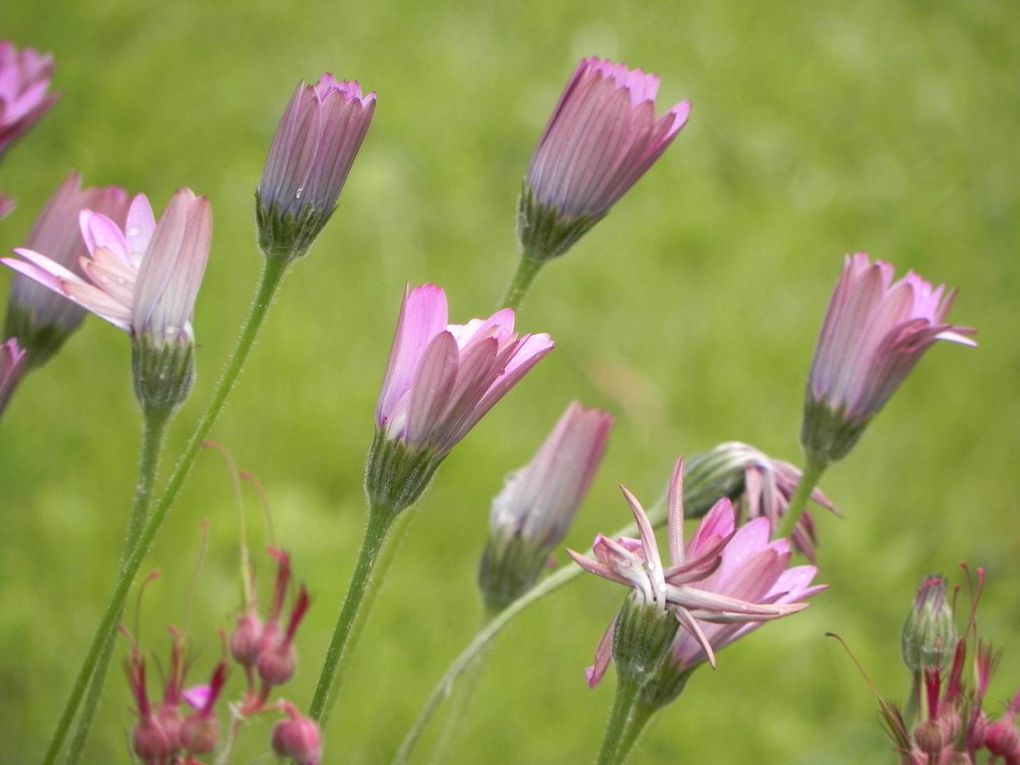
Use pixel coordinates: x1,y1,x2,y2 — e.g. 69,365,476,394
308,508,397,727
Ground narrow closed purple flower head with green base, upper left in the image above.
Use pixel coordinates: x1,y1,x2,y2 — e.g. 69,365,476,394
256,73,375,260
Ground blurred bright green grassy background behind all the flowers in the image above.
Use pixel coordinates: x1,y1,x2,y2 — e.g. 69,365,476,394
0,0,1020,765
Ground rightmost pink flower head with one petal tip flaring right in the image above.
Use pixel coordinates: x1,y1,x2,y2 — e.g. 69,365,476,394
801,253,977,465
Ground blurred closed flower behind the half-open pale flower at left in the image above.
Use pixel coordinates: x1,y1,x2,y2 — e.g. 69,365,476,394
4,172,129,367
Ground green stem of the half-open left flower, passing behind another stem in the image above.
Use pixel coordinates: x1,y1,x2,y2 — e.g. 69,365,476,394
67,411,169,765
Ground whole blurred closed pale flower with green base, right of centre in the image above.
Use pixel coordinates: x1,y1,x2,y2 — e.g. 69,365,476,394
478,401,613,610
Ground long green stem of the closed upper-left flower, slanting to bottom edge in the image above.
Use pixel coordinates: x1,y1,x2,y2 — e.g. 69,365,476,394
43,258,287,765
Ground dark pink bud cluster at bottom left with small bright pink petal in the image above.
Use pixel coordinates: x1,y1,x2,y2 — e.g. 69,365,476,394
126,630,226,765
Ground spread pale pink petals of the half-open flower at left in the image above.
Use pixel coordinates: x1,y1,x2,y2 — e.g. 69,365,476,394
3,189,212,346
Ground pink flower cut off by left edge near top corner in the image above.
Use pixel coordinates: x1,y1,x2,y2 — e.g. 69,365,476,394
0,40,59,157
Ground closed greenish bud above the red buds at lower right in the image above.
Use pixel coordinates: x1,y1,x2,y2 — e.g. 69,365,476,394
900,576,957,672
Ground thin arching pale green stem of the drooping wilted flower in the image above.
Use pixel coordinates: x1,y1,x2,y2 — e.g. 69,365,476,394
393,503,666,765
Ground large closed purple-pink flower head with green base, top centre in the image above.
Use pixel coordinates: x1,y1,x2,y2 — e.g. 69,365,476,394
518,58,691,260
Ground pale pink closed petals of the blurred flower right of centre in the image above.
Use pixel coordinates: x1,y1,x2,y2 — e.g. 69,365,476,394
490,401,613,550
